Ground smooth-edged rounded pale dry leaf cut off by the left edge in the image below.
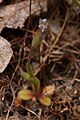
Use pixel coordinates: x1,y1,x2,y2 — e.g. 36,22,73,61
0,36,13,73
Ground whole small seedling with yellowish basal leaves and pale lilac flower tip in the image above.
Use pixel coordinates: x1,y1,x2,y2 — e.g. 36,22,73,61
18,19,55,106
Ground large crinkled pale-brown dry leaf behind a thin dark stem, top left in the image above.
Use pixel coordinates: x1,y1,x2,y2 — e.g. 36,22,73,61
0,0,47,32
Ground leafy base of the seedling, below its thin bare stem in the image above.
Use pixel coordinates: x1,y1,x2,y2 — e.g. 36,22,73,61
18,63,55,106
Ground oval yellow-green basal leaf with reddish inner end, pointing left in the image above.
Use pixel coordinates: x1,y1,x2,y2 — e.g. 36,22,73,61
18,90,34,100
